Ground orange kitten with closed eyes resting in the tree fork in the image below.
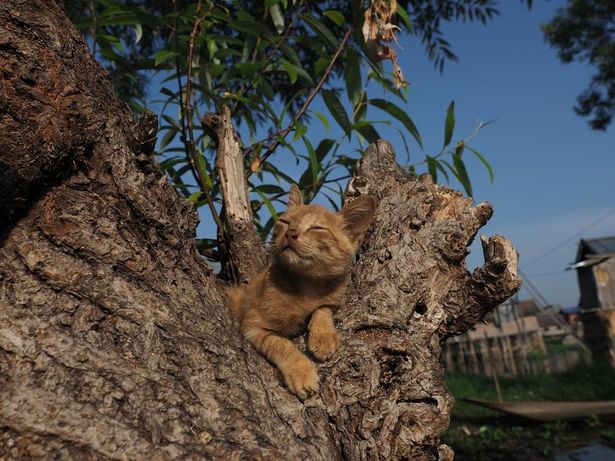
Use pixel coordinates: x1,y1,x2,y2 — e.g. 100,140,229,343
229,184,376,399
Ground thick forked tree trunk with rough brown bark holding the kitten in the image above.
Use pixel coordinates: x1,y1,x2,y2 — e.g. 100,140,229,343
0,0,519,460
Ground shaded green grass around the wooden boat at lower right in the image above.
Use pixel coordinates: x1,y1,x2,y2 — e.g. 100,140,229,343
443,366,615,461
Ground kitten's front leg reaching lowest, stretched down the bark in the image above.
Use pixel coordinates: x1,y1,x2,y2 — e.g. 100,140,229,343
245,327,319,400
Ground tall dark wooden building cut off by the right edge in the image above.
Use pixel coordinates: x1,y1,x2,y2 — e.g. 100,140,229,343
570,236,615,366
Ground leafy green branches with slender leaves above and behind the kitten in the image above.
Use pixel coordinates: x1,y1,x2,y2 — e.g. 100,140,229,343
66,0,516,268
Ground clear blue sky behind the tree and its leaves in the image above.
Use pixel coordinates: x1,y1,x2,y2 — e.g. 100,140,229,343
152,0,615,306
